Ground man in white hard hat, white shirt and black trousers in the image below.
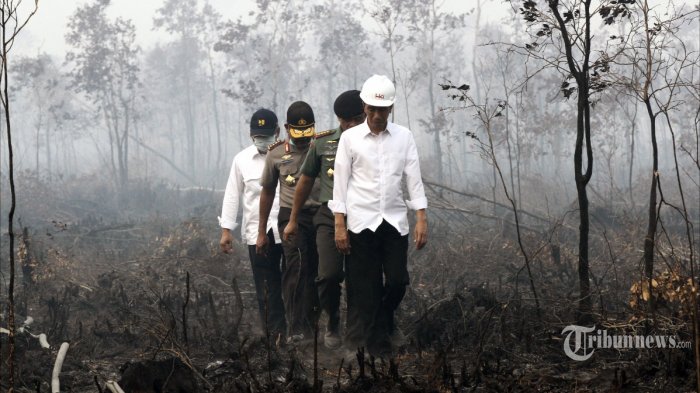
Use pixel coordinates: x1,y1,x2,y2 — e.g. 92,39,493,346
328,75,428,355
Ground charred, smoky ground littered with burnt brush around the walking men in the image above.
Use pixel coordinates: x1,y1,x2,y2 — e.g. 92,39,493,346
2,176,694,392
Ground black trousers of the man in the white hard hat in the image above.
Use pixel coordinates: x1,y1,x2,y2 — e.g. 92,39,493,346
345,221,409,354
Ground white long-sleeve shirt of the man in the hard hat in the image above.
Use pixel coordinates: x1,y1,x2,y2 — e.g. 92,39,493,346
328,121,428,236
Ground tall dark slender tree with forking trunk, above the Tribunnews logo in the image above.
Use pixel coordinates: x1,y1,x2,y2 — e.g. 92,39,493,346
511,0,629,323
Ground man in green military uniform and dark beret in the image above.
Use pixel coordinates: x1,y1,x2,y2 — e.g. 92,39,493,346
282,90,365,349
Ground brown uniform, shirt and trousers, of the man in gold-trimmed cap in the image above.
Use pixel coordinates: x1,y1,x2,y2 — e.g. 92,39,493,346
260,141,319,337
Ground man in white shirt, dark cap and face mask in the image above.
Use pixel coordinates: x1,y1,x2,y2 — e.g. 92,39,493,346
219,109,286,338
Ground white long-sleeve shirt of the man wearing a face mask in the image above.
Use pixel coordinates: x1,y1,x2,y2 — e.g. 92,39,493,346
219,145,280,245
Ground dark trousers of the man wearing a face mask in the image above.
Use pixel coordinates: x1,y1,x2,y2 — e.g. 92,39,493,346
248,231,287,337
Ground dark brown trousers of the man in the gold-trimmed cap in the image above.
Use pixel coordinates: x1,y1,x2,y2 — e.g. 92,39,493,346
277,207,318,337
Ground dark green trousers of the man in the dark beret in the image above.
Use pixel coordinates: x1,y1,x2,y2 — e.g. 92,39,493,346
314,203,345,333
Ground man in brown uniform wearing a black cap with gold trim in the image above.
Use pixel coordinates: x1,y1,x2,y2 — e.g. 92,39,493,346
256,101,320,342
